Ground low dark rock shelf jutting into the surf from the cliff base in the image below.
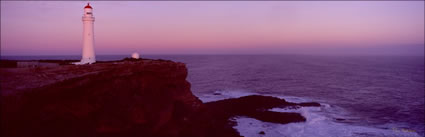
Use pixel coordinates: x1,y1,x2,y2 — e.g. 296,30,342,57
206,95,320,124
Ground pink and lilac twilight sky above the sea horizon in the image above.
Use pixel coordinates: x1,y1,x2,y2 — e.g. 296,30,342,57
1,1,425,56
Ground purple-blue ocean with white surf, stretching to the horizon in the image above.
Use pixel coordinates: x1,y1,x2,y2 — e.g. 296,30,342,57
1,55,425,137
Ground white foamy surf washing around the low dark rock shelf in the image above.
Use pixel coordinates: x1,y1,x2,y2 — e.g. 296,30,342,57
199,90,421,137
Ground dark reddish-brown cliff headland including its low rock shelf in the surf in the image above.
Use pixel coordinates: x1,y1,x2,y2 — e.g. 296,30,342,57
0,60,318,137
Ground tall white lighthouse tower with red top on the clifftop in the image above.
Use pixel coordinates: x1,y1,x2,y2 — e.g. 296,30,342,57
75,3,96,64
